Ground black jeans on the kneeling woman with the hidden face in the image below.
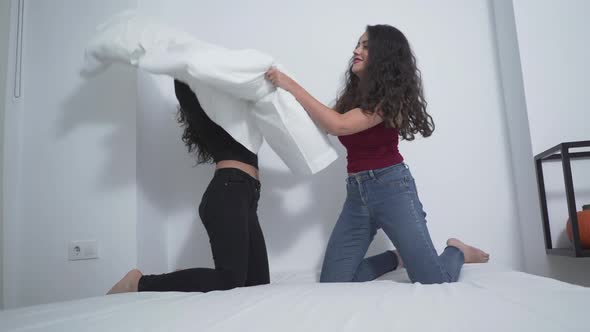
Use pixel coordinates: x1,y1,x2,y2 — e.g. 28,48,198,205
138,168,270,292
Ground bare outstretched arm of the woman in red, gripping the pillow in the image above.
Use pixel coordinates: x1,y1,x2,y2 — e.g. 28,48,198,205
266,67,383,136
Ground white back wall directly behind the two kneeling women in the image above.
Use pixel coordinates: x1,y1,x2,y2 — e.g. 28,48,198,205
137,0,522,273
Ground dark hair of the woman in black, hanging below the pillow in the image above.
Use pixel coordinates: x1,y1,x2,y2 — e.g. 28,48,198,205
174,80,214,165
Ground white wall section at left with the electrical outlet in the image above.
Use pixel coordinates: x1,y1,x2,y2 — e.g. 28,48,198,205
4,0,137,307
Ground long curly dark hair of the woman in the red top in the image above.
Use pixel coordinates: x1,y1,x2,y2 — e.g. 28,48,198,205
335,25,434,141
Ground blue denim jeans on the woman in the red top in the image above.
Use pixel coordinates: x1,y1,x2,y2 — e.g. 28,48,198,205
320,163,464,284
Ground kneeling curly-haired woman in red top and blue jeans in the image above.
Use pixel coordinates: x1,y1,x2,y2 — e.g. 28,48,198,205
266,25,489,284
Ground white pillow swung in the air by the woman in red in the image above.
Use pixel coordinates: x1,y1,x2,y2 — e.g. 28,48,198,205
82,12,338,174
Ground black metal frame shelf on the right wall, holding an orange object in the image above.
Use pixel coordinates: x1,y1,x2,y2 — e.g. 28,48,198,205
535,141,590,257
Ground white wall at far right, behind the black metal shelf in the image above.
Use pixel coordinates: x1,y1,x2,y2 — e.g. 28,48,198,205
514,0,590,286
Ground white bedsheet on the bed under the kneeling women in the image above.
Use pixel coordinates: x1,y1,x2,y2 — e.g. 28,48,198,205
0,265,590,332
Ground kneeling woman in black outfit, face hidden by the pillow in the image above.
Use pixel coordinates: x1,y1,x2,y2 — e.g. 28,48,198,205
108,80,270,294
